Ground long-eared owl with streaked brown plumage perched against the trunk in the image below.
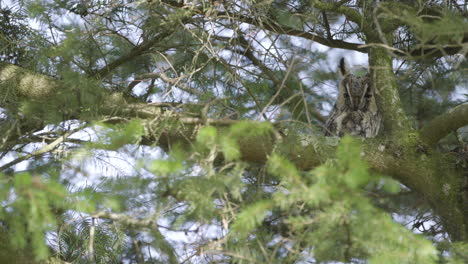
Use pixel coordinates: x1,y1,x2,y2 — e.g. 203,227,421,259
325,58,382,138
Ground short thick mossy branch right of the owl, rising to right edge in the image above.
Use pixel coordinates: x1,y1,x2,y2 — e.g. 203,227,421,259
419,103,468,145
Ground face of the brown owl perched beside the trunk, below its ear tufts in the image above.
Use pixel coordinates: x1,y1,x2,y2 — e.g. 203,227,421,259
339,74,373,111
